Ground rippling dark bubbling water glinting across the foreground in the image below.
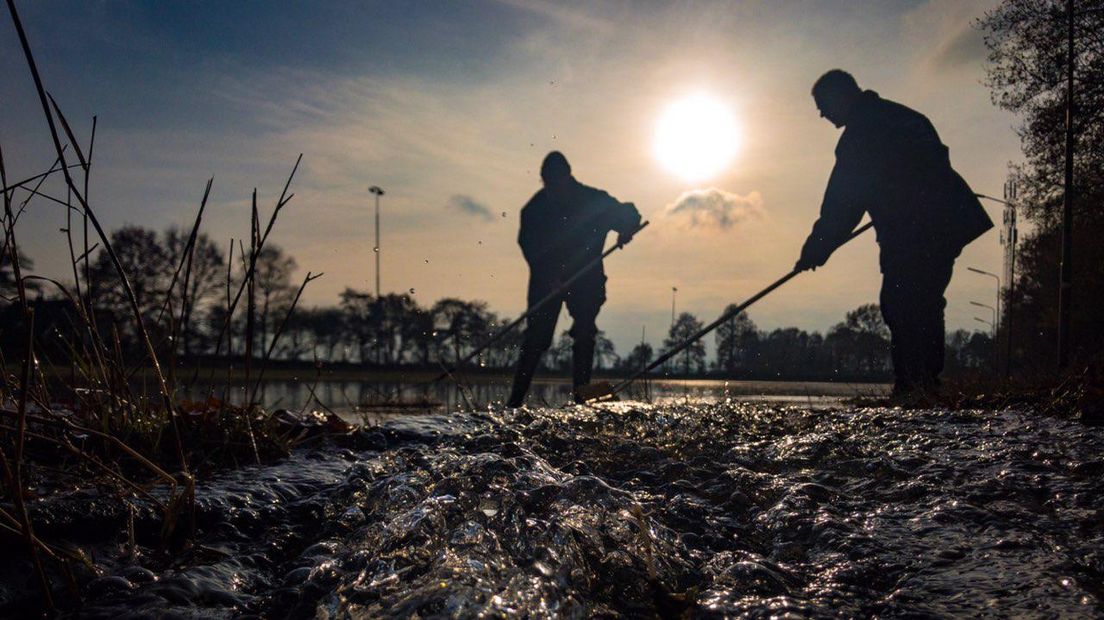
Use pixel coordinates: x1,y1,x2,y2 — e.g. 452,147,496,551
53,403,1104,619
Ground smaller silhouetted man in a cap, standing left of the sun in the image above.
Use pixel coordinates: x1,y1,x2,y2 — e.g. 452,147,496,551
507,151,640,407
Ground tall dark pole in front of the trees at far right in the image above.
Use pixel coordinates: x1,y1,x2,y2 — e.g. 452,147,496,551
1058,0,1074,371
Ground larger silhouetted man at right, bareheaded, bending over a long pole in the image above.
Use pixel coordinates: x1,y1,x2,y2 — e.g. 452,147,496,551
795,70,992,395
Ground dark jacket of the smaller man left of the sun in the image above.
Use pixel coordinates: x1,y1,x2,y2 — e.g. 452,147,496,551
518,179,640,289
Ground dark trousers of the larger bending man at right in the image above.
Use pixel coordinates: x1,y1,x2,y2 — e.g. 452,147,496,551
880,256,956,392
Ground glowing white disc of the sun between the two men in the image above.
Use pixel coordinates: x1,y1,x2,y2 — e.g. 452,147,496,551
654,95,740,183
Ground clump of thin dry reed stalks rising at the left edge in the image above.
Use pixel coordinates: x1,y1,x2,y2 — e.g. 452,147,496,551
0,0,320,606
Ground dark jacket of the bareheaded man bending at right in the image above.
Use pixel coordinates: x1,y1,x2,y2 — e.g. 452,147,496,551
802,90,992,270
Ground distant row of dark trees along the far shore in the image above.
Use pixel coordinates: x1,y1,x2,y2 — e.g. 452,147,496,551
0,225,992,381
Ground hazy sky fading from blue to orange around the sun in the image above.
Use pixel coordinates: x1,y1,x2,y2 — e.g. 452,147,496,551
0,0,1020,352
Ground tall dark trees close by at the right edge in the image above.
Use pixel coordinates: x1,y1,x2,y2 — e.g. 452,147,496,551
976,0,1104,374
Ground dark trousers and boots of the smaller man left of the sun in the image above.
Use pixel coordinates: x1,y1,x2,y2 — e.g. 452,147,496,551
507,277,606,406
